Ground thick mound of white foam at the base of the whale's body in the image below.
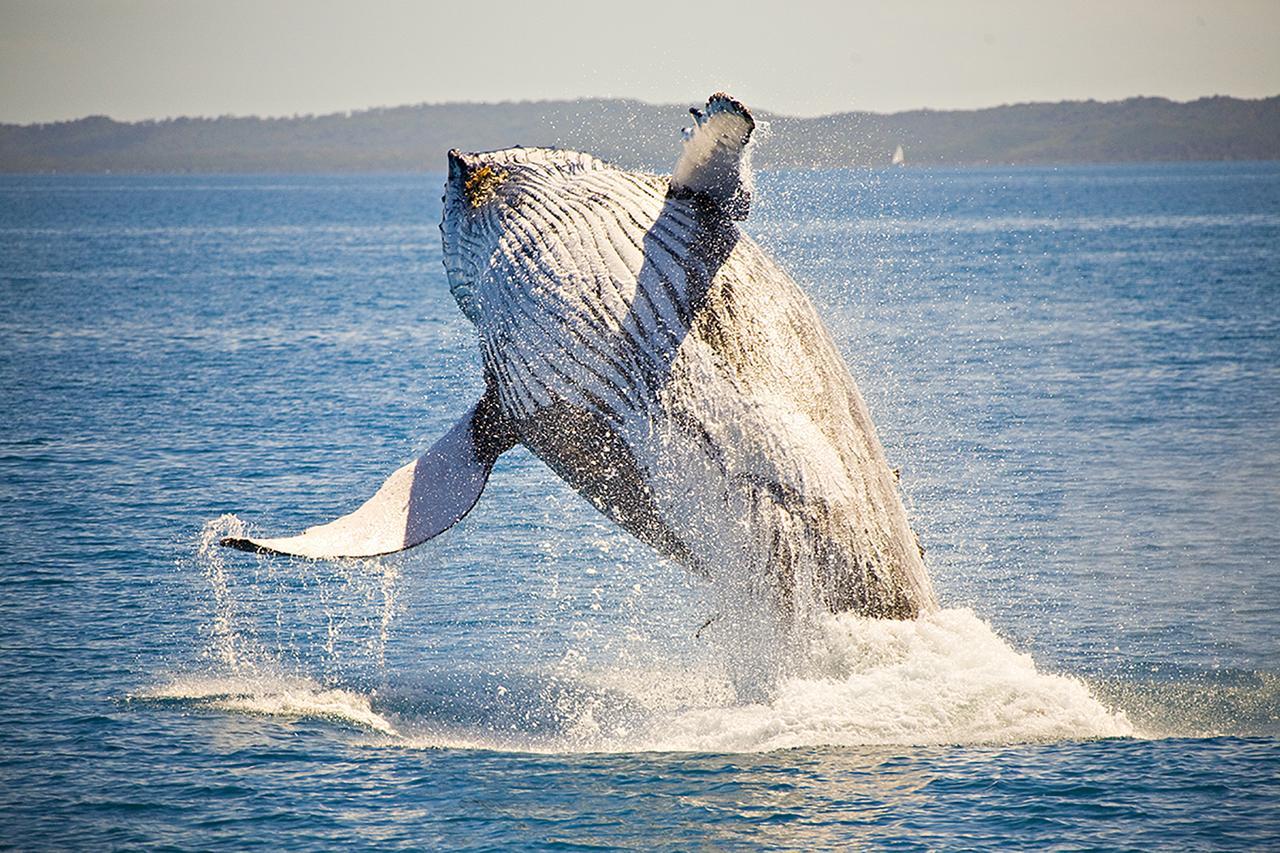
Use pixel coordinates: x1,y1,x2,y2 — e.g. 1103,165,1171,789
645,610,1134,752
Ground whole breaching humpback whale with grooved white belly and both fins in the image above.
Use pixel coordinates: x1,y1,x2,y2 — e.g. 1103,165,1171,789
221,93,936,619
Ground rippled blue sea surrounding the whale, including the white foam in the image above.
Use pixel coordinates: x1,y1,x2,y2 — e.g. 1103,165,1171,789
0,164,1280,849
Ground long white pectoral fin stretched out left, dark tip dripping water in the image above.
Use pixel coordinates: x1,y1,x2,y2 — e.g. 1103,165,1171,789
219,392,515,560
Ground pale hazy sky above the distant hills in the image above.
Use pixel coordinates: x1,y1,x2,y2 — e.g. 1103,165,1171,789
0,0,1280,122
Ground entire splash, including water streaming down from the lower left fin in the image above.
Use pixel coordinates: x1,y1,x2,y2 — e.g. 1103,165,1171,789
180,516,1138,753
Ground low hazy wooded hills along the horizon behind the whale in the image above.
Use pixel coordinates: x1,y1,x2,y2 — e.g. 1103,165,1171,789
0,96,1280,174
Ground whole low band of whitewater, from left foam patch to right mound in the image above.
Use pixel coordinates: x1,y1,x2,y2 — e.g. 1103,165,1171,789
145,608,1135,753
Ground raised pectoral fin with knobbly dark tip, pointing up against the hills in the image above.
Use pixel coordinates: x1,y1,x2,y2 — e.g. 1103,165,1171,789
671,92,755,219
